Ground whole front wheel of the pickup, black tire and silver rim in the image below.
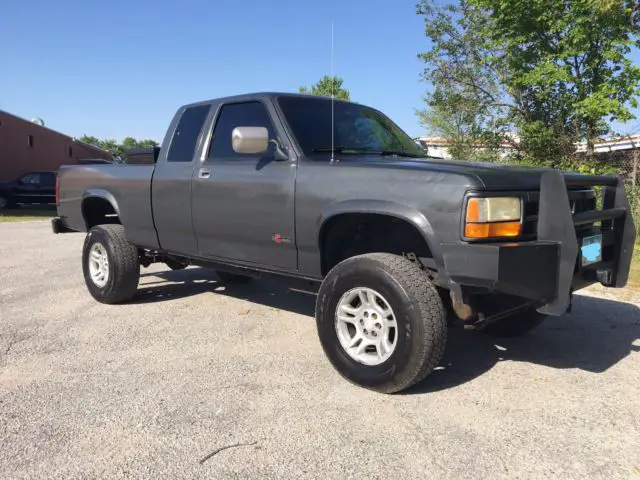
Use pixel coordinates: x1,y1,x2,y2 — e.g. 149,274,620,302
316,253,447,393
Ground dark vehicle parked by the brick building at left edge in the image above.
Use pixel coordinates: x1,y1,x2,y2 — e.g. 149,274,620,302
0,172,56,209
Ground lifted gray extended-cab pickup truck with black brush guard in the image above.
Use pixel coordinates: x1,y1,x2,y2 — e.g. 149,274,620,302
52,93,635,393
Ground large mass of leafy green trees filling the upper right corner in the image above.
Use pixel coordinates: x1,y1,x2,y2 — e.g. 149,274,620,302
418,0,640,159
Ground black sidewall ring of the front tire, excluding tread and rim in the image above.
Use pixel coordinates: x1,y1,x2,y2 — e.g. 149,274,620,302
316,260,424,389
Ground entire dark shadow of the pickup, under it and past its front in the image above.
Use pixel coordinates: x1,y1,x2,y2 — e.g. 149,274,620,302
133,268,640,395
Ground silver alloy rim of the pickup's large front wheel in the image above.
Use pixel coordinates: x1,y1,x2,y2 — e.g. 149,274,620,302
335,287,398,366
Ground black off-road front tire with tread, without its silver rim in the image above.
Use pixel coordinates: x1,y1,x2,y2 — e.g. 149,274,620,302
315,253,447,393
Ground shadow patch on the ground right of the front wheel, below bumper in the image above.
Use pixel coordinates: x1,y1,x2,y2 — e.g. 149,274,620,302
405,295,640,394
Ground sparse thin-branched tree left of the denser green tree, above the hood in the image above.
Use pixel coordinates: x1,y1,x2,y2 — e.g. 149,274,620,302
417,1,518,160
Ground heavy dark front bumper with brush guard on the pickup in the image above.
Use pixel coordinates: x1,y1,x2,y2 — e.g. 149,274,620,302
442,171,636,315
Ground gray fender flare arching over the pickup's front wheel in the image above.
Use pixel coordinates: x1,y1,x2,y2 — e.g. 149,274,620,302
316,199,443,268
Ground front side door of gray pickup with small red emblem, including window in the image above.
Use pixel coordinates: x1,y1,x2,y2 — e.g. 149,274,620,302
191,100,297,270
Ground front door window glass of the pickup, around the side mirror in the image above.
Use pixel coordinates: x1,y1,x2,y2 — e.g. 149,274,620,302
208,102,275,160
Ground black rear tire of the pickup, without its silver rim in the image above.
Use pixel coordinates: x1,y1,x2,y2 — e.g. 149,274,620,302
82,224,140,304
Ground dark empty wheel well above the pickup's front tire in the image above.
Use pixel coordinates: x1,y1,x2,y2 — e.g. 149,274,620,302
320,213,432,276
